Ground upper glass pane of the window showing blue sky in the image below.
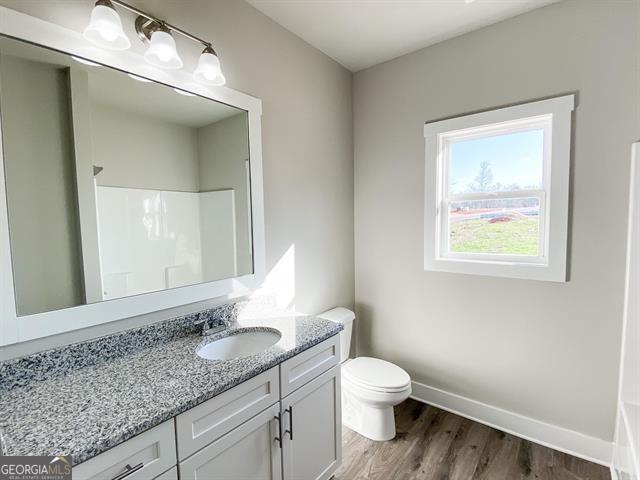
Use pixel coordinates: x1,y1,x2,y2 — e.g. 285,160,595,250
449,129,544,194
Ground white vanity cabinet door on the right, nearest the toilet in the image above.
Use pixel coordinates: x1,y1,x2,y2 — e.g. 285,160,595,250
282,365,342,480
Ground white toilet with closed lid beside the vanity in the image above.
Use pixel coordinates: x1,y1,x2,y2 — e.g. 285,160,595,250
318,307,411,441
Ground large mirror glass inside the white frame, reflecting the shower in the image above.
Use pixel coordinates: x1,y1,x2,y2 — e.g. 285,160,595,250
0,38,253,316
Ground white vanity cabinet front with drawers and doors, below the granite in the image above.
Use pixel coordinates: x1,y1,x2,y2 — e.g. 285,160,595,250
73,335,341,480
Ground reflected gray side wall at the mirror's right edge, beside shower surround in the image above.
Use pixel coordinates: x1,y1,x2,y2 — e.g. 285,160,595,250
198,112,253,275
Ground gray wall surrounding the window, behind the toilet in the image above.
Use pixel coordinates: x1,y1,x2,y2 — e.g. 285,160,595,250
354,1,640,440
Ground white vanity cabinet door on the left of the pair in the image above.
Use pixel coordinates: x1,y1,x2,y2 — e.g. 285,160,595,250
180,404,282,480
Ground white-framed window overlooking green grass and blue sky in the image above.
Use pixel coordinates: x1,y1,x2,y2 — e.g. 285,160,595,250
424,95,574,282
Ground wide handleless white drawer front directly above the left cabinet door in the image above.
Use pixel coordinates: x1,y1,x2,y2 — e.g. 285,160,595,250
176,367,279,460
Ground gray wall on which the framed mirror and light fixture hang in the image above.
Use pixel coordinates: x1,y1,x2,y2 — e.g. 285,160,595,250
0,0,354,359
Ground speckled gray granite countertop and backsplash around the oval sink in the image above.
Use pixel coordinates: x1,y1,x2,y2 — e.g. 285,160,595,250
0,306,342,464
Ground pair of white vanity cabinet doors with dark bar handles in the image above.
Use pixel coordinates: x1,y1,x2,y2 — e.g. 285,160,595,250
178,366,341,480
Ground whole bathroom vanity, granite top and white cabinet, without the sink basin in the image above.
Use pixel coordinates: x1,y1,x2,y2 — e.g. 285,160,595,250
0,308,341,480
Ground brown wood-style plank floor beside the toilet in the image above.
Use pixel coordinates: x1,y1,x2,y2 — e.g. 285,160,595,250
335,400,611,480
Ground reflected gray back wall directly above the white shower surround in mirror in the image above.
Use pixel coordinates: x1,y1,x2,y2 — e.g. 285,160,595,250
91,102,199,192
